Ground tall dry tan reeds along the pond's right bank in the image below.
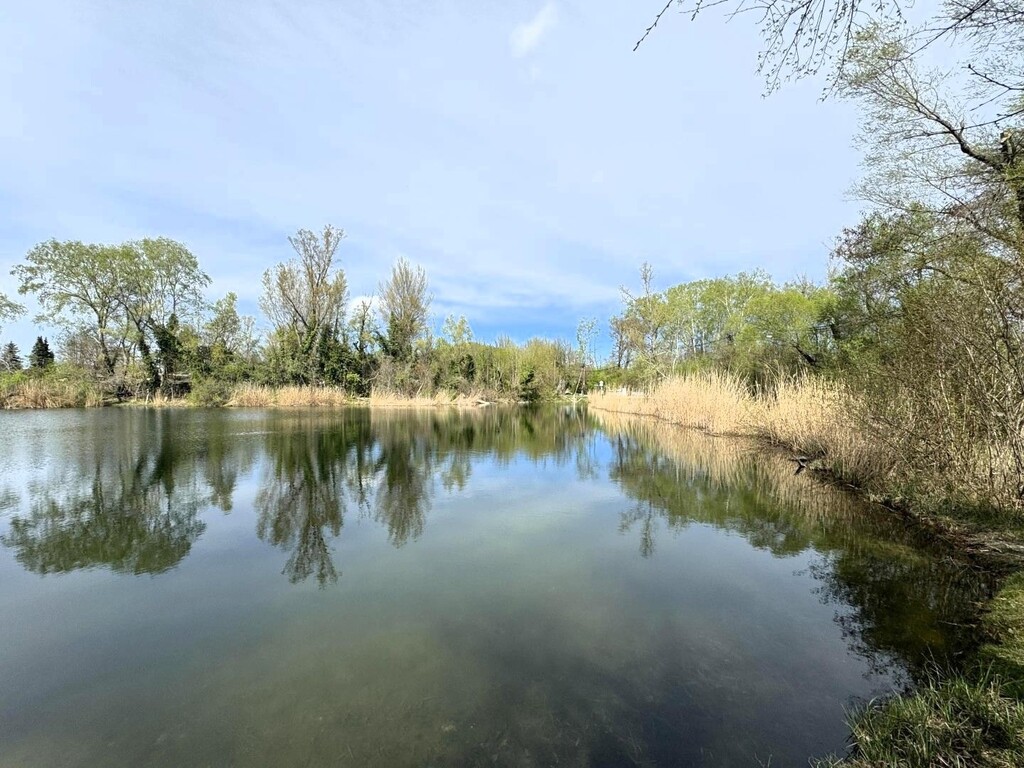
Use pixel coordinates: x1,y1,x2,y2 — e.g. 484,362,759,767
589,373,1024,528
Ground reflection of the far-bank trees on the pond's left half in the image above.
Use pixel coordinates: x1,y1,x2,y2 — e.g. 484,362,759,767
0,409,595,586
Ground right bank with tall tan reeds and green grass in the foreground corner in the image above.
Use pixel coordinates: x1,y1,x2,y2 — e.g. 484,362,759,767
589,373,1024,768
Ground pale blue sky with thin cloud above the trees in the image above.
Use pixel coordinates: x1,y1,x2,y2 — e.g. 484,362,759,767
0,0,859,349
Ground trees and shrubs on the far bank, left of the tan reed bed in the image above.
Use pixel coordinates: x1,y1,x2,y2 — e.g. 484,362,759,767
0,225,593,402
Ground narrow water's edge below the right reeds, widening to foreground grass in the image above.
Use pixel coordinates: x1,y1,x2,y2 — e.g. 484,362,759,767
588,395,1024,768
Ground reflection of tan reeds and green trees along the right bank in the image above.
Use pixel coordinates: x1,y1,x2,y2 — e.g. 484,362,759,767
601,415,993,677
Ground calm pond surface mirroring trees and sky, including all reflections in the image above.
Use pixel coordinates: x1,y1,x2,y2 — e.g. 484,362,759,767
0,410,988,768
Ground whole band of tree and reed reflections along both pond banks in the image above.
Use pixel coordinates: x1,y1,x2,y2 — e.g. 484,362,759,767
0,409,991,696
